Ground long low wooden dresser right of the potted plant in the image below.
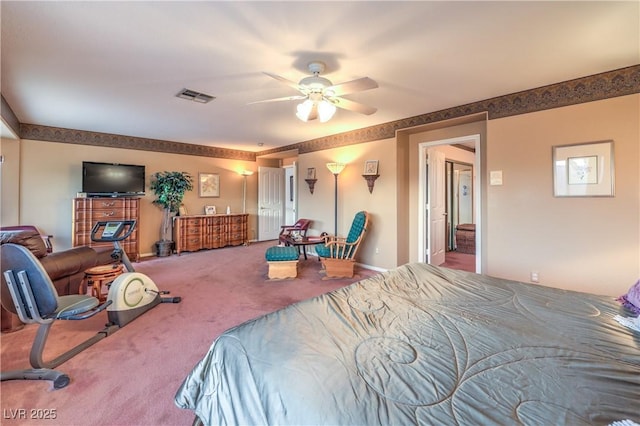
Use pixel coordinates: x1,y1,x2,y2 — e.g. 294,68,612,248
173,214,249,254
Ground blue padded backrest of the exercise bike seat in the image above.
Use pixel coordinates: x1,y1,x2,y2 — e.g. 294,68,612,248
0,243,58,319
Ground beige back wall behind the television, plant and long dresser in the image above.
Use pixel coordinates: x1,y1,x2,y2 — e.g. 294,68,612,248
11,140,258,255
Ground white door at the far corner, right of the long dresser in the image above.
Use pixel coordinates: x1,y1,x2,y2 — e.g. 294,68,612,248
258,167,284,241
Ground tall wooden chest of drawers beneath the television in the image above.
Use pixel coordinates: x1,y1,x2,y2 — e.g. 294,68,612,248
71,197,140,262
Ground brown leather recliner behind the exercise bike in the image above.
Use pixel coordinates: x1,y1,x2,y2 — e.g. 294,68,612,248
0,226,115,332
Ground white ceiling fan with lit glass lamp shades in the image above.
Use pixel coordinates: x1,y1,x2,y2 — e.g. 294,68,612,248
251,61,378,122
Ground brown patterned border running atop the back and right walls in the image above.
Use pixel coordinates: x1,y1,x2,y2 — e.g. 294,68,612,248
20,65,640,161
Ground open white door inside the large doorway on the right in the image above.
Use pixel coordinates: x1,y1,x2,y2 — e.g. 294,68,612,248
427,148,447,266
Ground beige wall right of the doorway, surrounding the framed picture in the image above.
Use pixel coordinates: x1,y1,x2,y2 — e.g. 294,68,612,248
486,95,640,296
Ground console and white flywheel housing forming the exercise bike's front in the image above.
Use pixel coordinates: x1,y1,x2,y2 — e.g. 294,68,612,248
91,220,181,327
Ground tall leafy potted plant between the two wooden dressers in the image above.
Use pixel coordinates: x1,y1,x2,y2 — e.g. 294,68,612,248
149,172,193,256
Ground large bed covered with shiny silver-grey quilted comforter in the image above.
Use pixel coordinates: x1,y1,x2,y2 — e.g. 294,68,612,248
175,263,640,425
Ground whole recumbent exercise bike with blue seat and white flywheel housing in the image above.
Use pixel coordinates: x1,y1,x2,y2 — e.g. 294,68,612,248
0,221,180,389
